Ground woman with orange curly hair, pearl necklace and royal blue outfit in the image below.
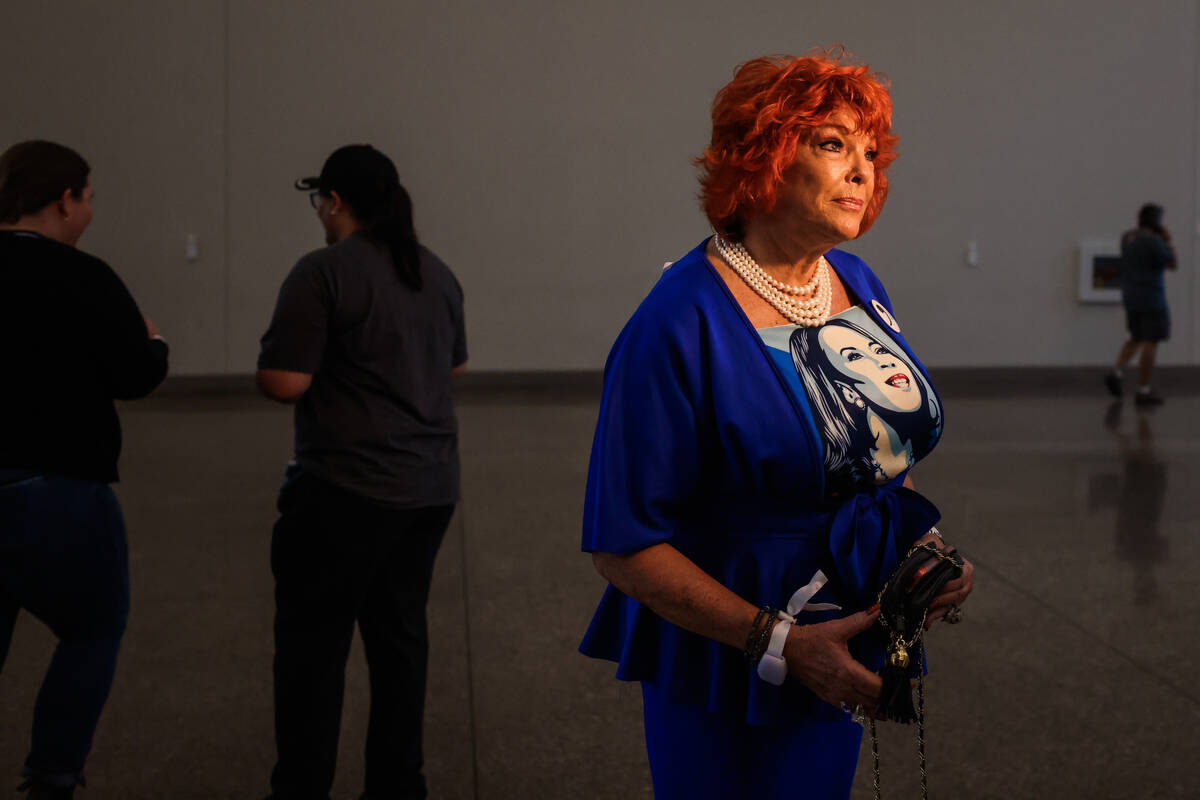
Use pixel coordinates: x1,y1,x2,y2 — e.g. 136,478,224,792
580,54,973,800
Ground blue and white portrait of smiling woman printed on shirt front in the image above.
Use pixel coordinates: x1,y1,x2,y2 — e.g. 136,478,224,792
790,307,942,491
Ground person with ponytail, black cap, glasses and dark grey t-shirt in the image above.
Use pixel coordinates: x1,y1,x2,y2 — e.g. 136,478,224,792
258,145,467,800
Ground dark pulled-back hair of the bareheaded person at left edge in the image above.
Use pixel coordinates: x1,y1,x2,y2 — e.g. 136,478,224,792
0,139,91,224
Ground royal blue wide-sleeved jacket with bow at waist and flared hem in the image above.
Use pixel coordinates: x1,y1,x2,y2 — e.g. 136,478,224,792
580,237,940,724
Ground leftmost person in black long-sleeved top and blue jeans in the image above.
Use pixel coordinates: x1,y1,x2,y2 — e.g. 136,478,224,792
0,142,167,800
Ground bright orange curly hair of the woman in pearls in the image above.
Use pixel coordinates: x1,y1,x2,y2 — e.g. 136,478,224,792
694,48,899,241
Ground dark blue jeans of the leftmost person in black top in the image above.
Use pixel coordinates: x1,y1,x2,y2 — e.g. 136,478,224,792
0,471,130,786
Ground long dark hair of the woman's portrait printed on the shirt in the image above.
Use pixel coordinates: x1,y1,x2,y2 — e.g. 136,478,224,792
790,319,942,492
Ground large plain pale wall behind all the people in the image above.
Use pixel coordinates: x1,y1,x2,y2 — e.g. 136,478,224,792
0,0,1200,374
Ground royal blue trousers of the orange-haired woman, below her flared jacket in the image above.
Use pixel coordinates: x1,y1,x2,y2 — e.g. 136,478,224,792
642,682,863,800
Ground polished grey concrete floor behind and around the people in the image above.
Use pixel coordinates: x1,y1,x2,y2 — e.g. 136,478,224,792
0,390,1200,800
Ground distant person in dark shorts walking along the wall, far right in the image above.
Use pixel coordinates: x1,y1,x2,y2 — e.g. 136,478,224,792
1104,203,1176,407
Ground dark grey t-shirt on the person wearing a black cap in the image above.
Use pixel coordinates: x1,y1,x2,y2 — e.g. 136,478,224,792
258,234,467,509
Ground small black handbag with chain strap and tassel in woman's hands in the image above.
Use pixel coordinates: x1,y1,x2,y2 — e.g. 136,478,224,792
870,542,964,800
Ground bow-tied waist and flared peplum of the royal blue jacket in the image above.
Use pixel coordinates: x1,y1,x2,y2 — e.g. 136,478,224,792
580,485,941,726
